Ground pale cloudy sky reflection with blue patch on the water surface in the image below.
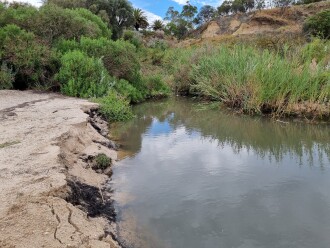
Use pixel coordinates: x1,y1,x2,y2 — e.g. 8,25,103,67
113,100,330,248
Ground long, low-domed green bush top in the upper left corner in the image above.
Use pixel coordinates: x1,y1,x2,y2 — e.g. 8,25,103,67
0,4,111,43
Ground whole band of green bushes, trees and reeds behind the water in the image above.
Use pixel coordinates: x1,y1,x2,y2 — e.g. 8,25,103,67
0,0,330,121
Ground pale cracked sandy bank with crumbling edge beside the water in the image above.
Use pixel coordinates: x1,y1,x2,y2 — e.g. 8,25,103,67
0,91,117,248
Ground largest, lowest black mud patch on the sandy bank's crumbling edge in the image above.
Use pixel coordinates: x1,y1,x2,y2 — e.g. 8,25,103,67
66,180,116,222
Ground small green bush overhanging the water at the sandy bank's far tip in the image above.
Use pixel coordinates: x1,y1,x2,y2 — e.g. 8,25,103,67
96,91,133,122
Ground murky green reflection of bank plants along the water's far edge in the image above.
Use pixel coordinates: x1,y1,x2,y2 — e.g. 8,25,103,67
114,98,330,165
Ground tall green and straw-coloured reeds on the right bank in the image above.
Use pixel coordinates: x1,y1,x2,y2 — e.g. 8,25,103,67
164,40,330,117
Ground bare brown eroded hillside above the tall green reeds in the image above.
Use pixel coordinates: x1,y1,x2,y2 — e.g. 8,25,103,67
179,1,330,46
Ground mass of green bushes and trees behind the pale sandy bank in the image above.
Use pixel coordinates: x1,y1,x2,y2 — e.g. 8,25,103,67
0,0,170,121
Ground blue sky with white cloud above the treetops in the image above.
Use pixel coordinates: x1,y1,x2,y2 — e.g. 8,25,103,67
0,0,222,22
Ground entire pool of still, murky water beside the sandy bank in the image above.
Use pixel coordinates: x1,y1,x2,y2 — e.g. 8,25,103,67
113,98,330,248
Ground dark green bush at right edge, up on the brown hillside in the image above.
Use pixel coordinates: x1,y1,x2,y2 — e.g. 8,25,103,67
303,10,330,39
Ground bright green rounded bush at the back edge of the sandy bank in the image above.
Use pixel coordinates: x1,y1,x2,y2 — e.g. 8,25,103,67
55,51,114,98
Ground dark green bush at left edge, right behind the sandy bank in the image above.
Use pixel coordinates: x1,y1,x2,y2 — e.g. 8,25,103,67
0,25,51,89
